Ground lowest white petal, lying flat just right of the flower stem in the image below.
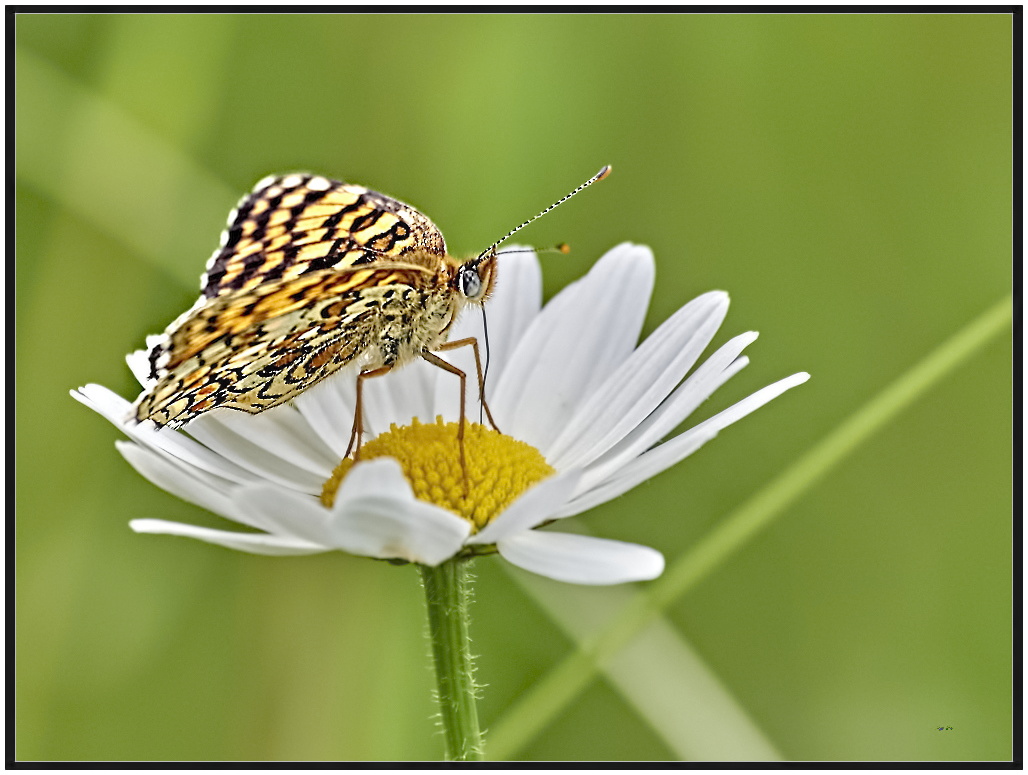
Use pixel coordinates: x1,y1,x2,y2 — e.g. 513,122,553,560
497,530,664,584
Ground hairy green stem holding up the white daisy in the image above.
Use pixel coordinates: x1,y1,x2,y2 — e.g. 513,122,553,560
419,558,482,762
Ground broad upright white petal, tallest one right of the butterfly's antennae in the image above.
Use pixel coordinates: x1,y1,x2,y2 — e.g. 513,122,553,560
491,245,654,453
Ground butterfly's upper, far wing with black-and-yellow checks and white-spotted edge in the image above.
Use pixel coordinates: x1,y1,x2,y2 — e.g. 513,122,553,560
200,174,446,299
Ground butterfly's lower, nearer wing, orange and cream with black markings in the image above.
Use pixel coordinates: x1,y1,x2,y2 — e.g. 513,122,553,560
136,263,426,428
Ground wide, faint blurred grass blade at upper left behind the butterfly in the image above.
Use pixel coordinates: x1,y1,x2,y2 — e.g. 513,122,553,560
15,47,238,287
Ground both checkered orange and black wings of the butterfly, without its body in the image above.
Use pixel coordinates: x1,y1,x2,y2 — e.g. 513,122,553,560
136,174,446,427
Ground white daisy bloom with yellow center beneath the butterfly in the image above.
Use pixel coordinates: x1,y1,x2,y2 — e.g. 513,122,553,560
72,244,809,584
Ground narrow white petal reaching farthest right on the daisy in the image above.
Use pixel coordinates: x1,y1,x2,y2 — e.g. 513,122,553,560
560,372,810,517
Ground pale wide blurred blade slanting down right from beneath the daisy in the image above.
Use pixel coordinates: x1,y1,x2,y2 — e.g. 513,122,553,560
503,566,781,762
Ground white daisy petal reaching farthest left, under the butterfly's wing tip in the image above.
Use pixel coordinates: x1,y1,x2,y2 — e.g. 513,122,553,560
71,384,257,483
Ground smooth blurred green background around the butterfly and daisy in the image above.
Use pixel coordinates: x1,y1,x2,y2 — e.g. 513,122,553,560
16,13,1020,760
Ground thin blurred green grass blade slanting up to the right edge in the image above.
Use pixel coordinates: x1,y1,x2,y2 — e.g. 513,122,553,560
486,296,1014,761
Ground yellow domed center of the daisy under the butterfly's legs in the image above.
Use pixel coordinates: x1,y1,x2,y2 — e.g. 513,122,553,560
321,417,556,531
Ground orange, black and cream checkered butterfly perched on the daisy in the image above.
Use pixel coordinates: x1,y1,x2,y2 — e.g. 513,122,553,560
134,167,611,456
